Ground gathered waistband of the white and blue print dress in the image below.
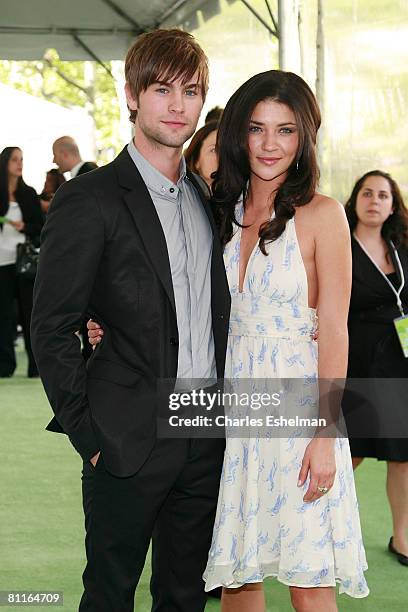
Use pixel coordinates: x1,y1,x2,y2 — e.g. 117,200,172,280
229,294,317,341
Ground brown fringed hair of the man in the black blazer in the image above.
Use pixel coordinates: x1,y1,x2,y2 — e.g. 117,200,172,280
125,28,208,123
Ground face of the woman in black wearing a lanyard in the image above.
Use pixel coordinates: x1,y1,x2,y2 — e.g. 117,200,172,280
356,176,393,227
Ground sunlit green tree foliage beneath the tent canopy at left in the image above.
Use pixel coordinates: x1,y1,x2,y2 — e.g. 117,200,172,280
0,50,122,162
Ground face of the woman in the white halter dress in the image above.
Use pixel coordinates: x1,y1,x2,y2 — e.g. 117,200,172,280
248,100,299,181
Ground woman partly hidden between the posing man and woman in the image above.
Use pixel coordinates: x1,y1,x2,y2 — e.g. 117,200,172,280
184,121,218,190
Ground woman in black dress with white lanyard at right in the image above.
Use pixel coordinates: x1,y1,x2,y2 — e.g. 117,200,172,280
346,170,408,566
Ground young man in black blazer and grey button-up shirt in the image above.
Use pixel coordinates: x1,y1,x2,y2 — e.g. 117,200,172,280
32,30,230,612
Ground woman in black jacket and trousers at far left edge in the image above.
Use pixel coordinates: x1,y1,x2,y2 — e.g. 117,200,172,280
0,147,42,377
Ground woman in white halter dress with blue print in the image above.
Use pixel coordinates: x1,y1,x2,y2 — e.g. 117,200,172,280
90,70,368,612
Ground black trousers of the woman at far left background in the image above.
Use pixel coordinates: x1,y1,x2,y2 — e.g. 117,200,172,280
0,264,38,376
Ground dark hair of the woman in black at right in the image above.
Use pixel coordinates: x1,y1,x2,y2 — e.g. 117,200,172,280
345,170,408,249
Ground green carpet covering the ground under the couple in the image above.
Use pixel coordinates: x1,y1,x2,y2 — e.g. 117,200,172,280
0,349,408,612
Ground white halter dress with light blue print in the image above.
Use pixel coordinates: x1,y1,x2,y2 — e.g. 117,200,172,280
204,203,369,597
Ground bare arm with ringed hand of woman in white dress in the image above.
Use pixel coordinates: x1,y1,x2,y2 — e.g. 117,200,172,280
299,197,352,501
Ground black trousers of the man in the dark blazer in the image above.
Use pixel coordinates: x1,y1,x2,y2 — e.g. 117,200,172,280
79,439,225,612
